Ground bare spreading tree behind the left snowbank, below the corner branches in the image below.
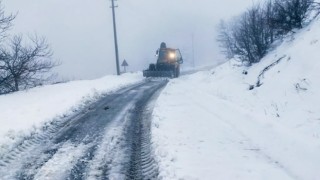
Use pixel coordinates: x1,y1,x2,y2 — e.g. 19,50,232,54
0,36,58,92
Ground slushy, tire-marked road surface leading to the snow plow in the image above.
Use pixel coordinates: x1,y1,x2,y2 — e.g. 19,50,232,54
0,80,167,179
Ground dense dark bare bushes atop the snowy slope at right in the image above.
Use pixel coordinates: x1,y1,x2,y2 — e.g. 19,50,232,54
218,0,318,65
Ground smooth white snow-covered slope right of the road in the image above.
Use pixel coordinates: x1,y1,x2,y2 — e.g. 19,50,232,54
152,20,320,180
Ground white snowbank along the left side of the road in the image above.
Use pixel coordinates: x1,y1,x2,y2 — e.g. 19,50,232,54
0,73,142,152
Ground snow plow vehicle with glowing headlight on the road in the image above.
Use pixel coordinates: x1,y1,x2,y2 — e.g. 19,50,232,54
143,42,183,78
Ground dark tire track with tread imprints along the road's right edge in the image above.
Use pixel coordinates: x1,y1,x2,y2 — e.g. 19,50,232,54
127,87,159,179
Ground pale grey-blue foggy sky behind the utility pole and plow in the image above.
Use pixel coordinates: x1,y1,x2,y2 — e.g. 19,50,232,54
2,0,258,79
